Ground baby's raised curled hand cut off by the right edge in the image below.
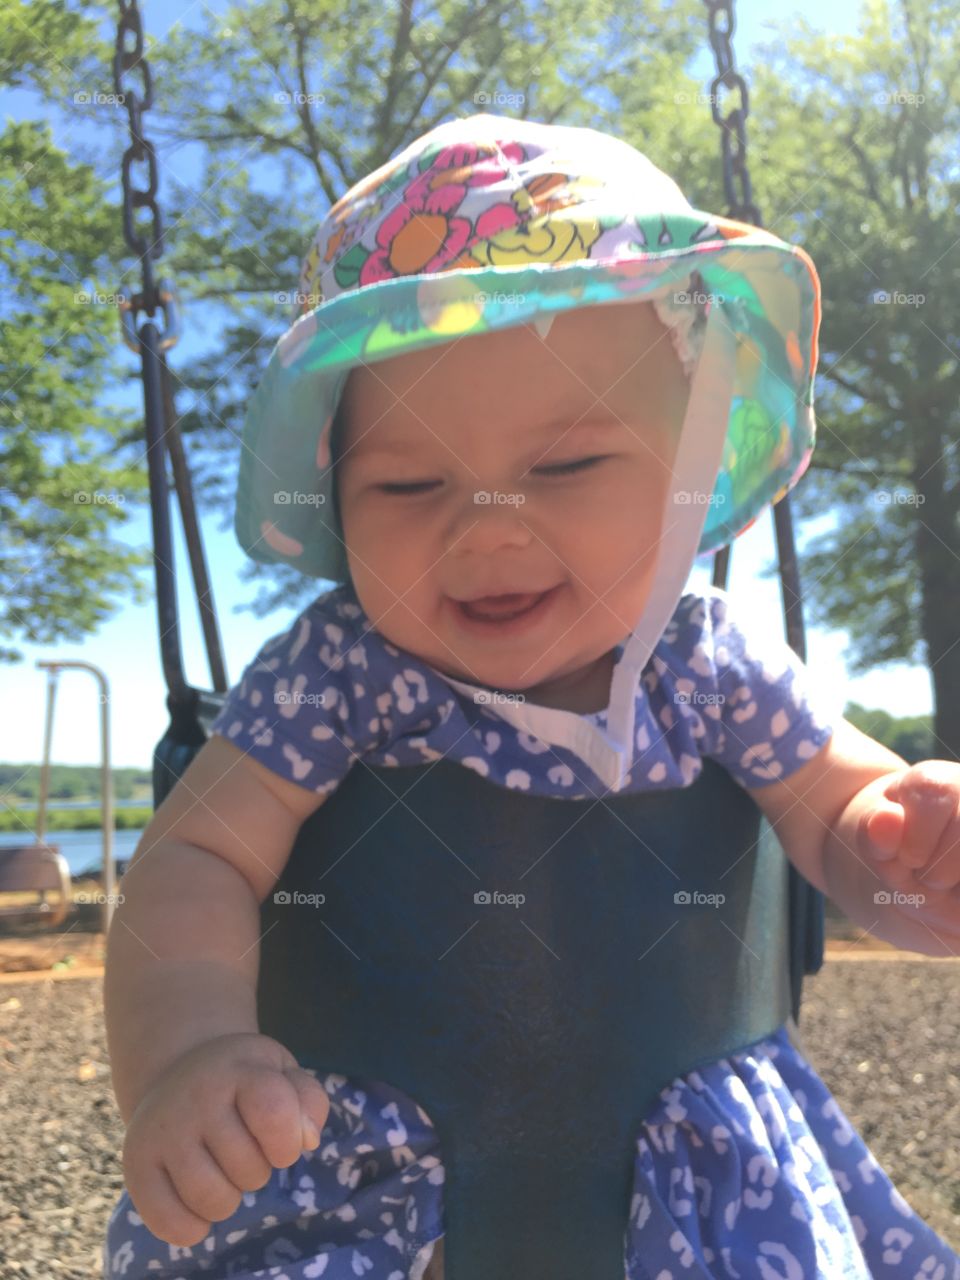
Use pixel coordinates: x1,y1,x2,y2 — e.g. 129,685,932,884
861,760,960,890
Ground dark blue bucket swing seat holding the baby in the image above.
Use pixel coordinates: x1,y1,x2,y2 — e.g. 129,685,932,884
155,675,822,1280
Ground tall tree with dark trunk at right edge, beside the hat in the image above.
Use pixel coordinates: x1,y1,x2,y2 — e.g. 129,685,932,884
751,0,960,759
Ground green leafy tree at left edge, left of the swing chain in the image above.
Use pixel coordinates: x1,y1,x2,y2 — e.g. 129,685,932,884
0,0,150,662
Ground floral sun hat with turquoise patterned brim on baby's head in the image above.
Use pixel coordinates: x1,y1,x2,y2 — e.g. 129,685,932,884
234,114,820,582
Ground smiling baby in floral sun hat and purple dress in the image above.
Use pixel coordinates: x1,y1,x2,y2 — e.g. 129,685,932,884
104,116,960,1280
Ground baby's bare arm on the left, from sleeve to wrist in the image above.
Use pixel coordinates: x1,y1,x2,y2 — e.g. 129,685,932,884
104,735,321,1121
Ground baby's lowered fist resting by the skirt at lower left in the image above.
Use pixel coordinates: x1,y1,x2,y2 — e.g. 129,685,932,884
123,1033,330,1247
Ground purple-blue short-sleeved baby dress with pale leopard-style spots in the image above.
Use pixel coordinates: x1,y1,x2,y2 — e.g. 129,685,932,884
104,586,960,1280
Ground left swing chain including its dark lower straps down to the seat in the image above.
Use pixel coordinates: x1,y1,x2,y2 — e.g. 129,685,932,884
113,0,228,706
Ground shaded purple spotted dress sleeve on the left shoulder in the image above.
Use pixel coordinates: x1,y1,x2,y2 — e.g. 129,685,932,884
211,598,380,796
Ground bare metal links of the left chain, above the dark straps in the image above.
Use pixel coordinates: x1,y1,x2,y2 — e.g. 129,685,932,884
113,0,180,352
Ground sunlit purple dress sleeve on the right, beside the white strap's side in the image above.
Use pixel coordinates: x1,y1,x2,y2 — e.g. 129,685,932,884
700,588,836,787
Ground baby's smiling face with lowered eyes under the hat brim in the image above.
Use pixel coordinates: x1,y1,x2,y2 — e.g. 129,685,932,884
338,303,687,700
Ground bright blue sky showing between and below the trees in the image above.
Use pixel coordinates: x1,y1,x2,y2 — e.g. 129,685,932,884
0,0,932,768
